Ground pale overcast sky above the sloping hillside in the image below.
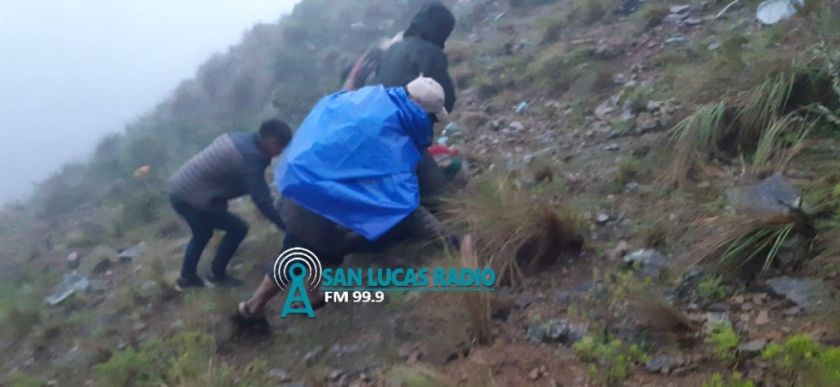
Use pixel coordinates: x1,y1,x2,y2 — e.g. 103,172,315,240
0,0,298,203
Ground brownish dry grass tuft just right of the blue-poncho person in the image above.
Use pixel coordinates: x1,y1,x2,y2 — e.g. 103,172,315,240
444,176,584,286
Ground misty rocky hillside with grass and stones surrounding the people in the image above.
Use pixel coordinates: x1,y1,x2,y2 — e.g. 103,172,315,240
0,0,840,386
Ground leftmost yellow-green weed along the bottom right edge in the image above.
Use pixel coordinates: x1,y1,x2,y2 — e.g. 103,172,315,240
574,336,648,386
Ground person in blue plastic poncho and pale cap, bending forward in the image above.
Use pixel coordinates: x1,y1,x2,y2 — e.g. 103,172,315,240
237,74,456,324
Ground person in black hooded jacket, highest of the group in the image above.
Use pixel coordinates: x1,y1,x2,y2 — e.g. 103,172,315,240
373,2,455,211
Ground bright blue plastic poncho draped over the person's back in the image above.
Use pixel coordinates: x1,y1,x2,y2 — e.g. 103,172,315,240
274,86,432,240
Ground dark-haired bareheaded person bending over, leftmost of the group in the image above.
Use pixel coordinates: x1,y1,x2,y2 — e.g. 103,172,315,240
169,119,292,291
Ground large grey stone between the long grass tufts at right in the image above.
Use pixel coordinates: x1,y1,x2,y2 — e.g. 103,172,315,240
726,173,802,214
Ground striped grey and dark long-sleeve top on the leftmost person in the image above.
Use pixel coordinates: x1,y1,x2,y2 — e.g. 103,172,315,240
169,133,285,229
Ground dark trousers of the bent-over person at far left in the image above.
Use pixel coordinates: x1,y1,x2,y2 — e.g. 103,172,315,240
169,196,248,278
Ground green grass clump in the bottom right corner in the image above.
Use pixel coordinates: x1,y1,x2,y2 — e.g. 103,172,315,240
761,334,840,386
